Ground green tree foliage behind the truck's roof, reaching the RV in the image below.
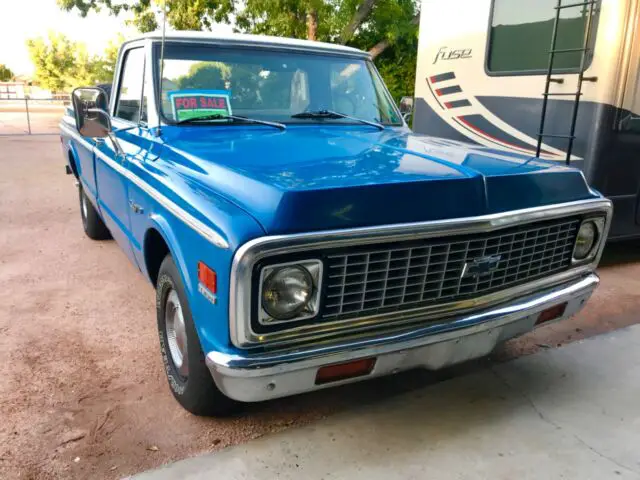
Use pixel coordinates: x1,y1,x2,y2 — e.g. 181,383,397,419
57,0,419,99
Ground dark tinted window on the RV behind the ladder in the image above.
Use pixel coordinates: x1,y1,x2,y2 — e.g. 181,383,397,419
487,0,597,74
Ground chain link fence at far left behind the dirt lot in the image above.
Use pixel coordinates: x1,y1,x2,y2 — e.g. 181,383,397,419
0,94,71,136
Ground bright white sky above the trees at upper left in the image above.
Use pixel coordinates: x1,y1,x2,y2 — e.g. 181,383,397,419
0,0,135,75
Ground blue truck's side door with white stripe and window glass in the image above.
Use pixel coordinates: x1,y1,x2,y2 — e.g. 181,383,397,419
95,47,145,263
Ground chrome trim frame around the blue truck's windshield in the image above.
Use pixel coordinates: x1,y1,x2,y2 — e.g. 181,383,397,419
151,39,406,127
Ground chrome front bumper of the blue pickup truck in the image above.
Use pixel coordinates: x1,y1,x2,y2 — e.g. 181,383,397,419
206,273,599,402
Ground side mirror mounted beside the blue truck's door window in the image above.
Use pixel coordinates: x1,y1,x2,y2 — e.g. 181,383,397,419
71,87,111,138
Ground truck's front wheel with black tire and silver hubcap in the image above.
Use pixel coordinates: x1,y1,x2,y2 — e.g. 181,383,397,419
156,255,241,417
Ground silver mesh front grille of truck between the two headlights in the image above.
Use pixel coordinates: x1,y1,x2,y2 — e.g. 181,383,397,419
321,217,580,321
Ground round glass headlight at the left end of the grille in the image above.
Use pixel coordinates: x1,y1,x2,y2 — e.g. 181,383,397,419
262,266,313,320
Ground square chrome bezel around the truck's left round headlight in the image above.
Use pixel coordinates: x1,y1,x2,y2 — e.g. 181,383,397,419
257,259,323,327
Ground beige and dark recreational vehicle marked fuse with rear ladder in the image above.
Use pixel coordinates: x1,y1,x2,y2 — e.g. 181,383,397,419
413,0,640,239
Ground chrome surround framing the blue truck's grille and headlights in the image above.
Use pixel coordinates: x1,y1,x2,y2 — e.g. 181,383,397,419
228,199,613,349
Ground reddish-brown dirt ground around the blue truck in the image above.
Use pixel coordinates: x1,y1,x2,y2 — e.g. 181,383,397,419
0,136,640,479
